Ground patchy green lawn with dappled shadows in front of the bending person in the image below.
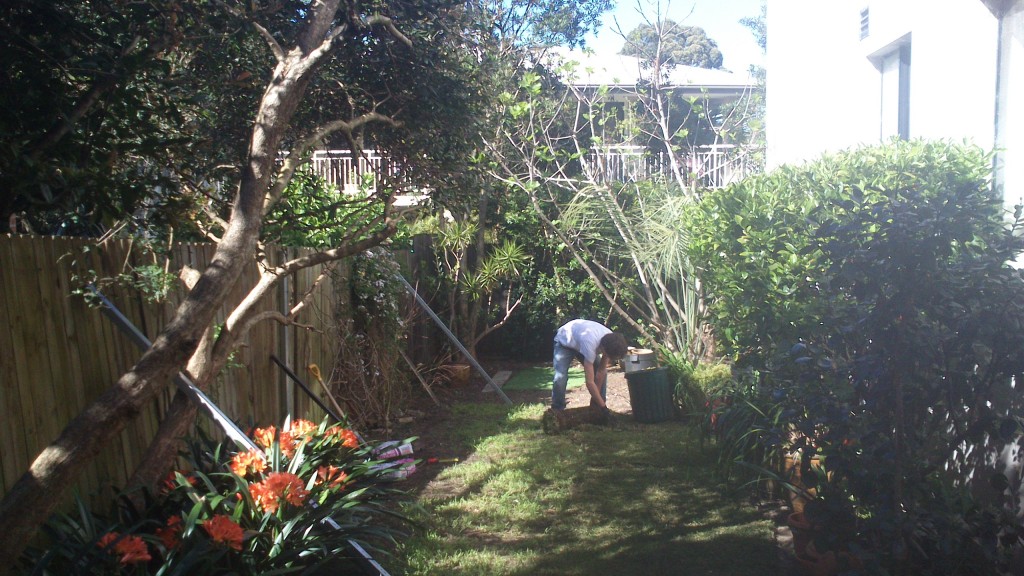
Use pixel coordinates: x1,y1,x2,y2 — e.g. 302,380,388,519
389,404,778,576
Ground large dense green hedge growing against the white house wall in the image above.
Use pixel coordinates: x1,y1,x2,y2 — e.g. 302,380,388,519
694,141,1024,574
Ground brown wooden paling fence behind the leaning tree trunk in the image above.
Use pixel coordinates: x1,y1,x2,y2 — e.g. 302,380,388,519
0,235,348,502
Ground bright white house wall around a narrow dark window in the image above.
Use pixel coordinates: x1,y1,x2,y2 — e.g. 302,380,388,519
766,0,998,166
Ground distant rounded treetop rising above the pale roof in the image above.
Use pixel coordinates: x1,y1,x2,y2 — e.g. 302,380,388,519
621,19,722,70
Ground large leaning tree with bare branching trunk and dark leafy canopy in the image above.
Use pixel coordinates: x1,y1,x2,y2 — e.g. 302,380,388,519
0,0,480,572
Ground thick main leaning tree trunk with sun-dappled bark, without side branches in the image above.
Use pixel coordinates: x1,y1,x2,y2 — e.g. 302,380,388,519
0,0,339,574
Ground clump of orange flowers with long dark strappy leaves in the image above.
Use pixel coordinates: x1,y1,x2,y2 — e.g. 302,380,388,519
27,420,415,575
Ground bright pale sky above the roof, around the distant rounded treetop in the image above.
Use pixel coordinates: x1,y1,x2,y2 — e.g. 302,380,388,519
587,0,764,73
